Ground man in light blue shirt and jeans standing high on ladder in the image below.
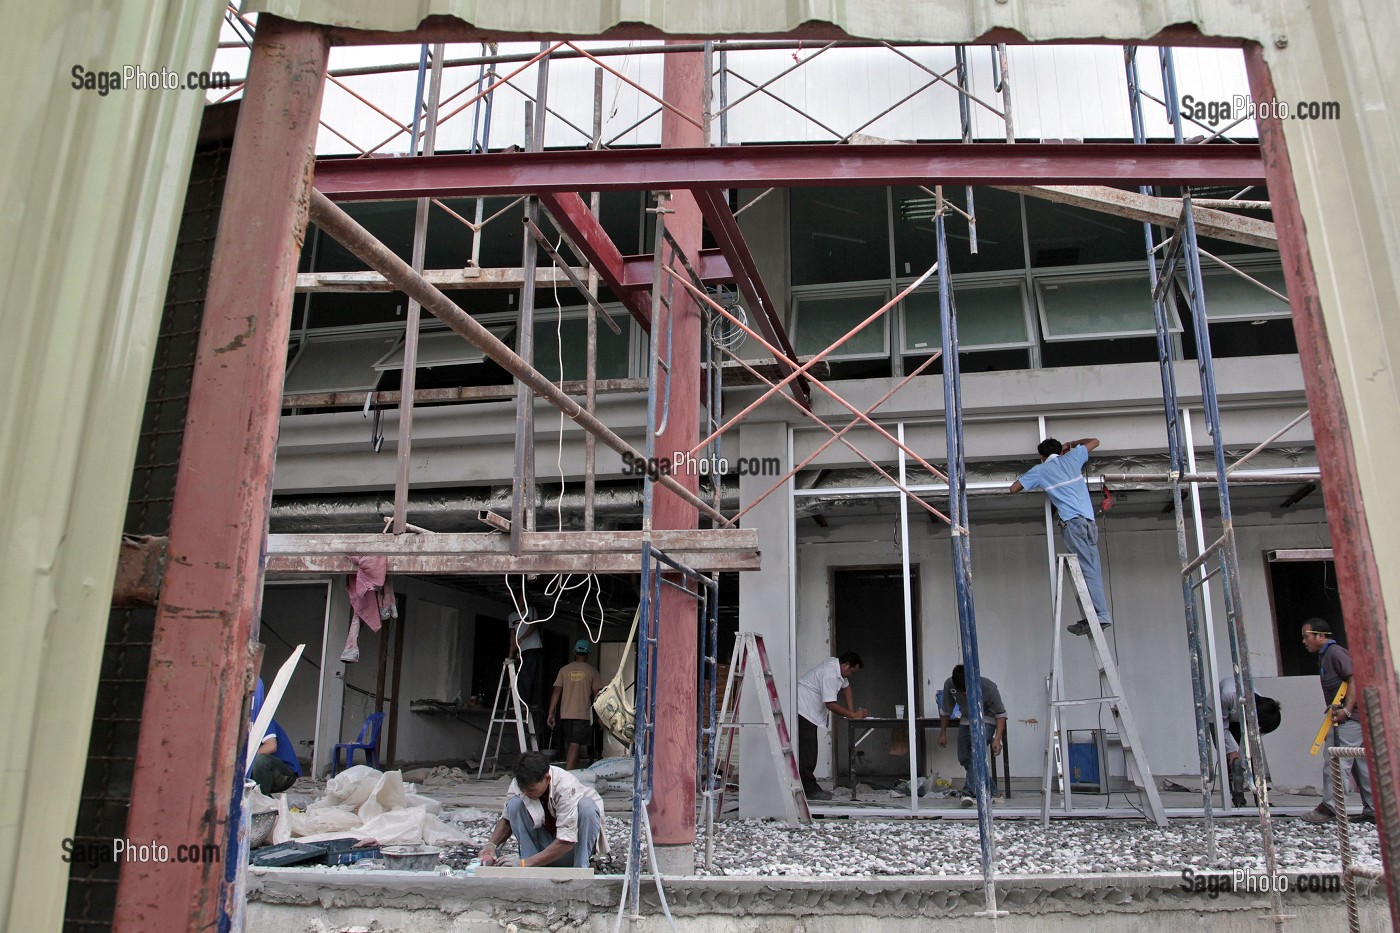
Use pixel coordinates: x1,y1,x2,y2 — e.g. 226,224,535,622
1011,437,1113,635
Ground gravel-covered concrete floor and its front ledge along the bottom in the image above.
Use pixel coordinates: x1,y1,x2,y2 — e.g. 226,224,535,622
248,776,1389,933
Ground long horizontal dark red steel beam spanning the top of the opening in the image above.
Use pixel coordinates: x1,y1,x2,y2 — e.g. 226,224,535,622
316,141,1264,203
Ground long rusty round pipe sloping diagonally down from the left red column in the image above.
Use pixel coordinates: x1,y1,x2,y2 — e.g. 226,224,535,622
311,189,731,525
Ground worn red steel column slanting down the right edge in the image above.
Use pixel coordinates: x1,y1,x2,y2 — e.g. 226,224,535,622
1245,45,1400,929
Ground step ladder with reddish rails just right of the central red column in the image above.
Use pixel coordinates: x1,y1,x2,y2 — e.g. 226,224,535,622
710,632,812,827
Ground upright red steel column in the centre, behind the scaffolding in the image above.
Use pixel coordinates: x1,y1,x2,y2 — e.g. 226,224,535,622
650,45,706,871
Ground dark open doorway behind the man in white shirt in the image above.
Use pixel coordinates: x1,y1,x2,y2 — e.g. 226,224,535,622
830,565,923,783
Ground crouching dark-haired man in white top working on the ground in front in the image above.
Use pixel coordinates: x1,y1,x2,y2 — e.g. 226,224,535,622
482,752,608,869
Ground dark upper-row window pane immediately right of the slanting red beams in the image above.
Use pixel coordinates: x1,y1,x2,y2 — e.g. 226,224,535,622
788,188,889,284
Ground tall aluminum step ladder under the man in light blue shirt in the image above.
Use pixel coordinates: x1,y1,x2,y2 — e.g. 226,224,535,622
1040,553,1166,827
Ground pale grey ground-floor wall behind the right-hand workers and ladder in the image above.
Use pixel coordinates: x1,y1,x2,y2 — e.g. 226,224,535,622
778,498,1327,789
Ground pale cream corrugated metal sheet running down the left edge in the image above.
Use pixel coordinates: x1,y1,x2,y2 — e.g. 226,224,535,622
0,0,221,930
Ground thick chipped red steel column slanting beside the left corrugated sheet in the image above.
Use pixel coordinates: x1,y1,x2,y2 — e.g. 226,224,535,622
113,15,329,933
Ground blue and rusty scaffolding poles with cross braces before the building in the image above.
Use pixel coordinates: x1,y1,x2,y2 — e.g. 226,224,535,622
260,29,1310,919
